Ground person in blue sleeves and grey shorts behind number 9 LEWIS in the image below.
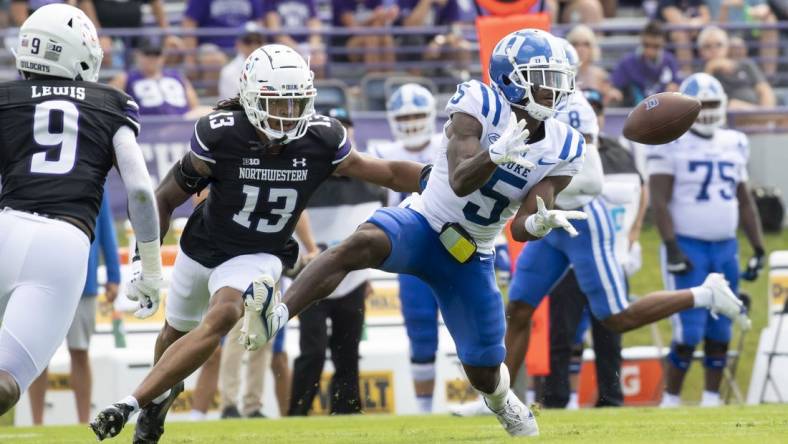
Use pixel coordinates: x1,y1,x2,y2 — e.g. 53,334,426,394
28,189,120,425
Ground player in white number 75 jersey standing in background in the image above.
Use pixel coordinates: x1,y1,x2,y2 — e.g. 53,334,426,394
647,73,764,407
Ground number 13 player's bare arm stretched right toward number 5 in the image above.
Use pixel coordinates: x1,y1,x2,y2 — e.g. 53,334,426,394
335,150,425,193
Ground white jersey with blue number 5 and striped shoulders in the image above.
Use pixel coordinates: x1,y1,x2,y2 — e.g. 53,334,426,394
408,80,585,254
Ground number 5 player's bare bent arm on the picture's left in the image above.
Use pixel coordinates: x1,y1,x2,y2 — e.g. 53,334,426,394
446,112,498,197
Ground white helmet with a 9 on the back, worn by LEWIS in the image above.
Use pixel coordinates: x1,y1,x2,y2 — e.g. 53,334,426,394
16,3,104,82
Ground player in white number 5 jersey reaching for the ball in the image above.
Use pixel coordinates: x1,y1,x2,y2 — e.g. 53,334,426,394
266,29,584,436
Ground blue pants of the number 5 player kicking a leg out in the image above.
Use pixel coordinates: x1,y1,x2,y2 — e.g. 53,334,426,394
368,208,506,367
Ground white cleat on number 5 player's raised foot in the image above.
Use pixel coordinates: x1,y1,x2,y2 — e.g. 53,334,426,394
238,275,281,350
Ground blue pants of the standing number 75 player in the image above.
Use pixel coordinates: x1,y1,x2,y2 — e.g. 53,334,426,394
662,236,739,346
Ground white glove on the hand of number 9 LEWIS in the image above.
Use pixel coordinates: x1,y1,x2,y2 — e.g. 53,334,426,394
126,239,163,319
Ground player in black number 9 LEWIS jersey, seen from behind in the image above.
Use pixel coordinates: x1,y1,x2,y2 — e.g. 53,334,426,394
0,4,161,415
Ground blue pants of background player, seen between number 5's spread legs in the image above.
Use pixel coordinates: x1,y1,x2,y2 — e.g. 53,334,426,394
399,274,438,364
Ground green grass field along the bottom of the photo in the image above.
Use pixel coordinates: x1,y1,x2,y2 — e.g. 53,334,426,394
0,406,788,444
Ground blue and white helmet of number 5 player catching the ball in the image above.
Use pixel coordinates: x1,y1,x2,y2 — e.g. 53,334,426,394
490,29,575,120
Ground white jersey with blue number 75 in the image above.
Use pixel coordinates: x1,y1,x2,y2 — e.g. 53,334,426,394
646,129,750,241
